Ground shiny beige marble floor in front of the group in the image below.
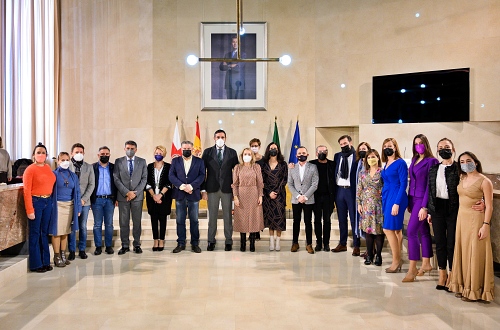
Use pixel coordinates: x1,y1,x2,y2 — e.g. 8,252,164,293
0,242,500,330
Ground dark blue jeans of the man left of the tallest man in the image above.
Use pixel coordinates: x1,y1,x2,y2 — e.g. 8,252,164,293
175,199,200,246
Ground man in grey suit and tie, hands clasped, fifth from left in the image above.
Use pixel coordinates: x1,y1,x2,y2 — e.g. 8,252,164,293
113,141,148,255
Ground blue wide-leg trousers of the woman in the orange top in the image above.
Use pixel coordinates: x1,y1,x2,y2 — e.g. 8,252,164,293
28,197,52,270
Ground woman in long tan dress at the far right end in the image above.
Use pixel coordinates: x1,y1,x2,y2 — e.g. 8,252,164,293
448,151,495,301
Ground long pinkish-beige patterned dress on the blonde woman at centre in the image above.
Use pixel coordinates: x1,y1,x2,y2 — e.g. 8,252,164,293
231,164,264,233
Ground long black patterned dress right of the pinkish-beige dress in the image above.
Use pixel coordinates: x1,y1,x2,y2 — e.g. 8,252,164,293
262,162,288,231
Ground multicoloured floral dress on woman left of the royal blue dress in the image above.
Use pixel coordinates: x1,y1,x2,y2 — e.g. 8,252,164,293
356,168,384,235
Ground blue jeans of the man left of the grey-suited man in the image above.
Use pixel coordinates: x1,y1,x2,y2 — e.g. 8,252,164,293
92,198,115,247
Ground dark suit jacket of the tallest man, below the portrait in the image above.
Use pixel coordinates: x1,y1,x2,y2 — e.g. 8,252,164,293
201,146,239,194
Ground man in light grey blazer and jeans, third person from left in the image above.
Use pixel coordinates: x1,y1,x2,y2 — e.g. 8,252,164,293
68,143,95,260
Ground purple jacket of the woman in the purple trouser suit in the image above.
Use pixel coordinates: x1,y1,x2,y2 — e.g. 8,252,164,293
408,157,439,209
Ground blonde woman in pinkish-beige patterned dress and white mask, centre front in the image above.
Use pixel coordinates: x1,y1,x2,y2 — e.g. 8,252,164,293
231,148,264,252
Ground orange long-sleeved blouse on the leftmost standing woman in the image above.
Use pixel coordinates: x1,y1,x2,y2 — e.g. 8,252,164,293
23,164,56,214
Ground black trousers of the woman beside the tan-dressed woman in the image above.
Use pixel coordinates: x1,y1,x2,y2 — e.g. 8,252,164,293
431,198,458,269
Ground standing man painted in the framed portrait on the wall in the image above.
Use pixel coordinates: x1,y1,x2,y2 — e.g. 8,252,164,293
219,37,246,99
